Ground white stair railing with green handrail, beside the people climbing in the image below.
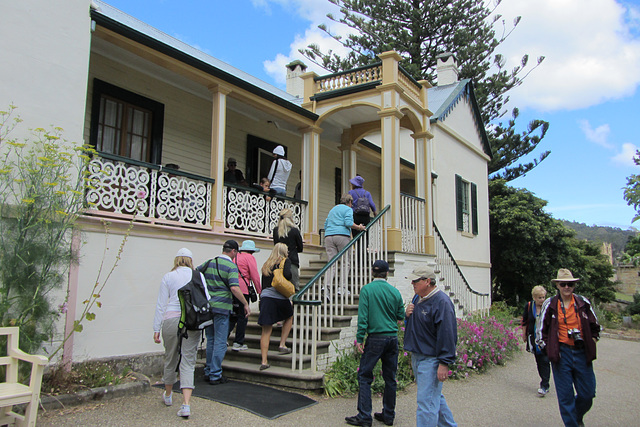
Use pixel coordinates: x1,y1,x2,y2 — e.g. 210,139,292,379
291,206,389,372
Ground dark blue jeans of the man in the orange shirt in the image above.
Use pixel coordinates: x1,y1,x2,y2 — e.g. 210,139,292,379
551,344,596,427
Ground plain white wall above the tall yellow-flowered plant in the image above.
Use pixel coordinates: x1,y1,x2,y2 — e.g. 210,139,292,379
0,0,91,142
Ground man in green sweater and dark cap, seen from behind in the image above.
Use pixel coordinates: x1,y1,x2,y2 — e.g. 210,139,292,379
344,260,404,426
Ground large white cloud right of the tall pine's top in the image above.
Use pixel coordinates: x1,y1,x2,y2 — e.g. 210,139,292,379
498,0,640,111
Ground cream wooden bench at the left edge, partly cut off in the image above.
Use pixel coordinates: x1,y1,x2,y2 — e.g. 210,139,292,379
0,327,49,426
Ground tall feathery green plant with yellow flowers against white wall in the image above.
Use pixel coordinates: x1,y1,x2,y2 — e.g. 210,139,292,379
0,106,88,352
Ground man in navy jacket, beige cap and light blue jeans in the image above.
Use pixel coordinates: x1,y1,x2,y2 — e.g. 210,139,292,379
404,267,458,427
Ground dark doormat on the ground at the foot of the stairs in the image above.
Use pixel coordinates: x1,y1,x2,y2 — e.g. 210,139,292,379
153,376,318,420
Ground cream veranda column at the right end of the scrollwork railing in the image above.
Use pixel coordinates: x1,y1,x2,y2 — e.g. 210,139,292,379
301,126,322,245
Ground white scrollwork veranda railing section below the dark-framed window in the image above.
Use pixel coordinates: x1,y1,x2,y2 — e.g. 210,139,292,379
86,154,213,228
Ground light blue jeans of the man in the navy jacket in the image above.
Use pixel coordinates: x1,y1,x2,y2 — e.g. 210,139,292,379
411,353,457,427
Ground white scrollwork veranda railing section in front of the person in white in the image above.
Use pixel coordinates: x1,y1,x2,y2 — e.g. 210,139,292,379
224,185,307,237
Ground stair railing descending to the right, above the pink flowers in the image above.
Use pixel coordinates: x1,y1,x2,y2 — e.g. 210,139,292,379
433,224,491,315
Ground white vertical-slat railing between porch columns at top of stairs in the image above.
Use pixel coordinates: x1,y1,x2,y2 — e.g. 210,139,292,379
400,194,427,254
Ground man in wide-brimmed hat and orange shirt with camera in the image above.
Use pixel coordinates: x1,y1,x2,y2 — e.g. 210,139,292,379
536,268,600,427
